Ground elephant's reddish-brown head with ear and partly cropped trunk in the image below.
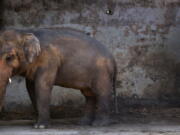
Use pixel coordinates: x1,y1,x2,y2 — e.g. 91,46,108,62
0,30,41,111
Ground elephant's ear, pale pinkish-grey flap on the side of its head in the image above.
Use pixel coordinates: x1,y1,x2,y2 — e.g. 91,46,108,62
23,33,41,63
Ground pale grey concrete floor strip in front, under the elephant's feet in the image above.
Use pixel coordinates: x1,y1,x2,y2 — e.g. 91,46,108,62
0,120,180,135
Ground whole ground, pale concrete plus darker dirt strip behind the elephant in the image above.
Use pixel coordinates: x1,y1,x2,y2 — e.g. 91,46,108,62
0,108,180,135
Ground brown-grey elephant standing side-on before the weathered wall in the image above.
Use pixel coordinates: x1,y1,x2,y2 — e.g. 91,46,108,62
0,28,117,128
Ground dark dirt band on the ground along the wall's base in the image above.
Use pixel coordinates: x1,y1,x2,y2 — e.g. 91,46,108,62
0,107,180,125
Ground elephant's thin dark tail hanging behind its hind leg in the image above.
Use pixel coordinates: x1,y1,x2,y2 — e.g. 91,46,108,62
113,61,119,113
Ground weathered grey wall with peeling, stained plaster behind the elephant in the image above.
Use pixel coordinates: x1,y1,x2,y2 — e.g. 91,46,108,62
3,0,180,110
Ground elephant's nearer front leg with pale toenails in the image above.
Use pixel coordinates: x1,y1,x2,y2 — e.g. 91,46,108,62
34,68,57,128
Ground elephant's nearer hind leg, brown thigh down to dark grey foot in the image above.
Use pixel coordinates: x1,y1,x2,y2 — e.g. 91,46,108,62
93,71,113,126
